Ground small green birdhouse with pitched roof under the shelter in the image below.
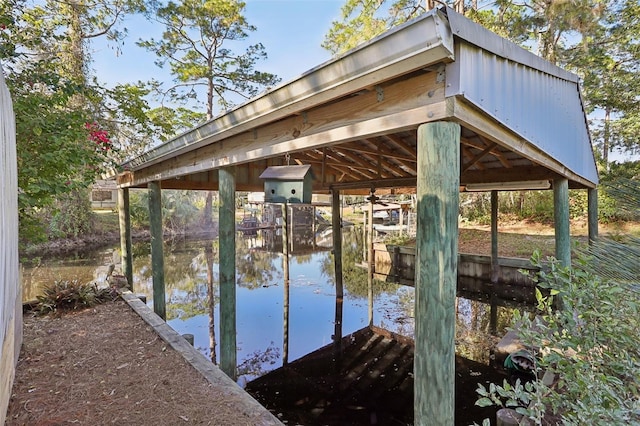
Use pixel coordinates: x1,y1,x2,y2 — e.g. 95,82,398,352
260,164,313,204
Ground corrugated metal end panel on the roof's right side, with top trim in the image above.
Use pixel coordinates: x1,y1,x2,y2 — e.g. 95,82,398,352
446,12,598,183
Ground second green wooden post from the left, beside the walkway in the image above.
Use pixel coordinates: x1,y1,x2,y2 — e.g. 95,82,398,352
148,182,167,320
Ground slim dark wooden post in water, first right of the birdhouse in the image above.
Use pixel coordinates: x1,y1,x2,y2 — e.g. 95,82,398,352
331,189,344,361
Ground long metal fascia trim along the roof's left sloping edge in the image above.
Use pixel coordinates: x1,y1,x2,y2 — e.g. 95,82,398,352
122,10,454,170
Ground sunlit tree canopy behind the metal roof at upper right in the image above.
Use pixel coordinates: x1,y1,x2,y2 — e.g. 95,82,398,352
323,0,640,164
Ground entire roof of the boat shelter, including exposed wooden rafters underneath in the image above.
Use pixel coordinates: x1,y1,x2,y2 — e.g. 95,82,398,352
118,8,598,192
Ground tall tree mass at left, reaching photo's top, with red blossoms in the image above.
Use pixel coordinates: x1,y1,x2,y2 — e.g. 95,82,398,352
0,0,158,242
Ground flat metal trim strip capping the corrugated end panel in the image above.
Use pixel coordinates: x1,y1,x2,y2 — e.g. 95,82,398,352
443,6,579,83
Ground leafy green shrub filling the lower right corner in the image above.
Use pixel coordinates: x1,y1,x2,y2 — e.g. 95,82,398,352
478,254,640,425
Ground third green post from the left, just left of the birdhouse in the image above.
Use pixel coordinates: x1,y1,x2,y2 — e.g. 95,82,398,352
218,167,237,380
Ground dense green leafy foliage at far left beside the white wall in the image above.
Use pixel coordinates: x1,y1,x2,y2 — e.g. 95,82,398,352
7,64,116,241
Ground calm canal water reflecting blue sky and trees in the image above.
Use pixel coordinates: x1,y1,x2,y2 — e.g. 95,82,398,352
23,227,536,423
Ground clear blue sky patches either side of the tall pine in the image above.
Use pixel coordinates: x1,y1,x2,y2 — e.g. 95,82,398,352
92,0,344,93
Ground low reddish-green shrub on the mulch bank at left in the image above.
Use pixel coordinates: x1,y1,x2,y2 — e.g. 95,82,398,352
37,280,117,315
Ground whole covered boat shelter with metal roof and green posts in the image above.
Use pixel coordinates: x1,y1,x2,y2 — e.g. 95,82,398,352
118,8,598,425
